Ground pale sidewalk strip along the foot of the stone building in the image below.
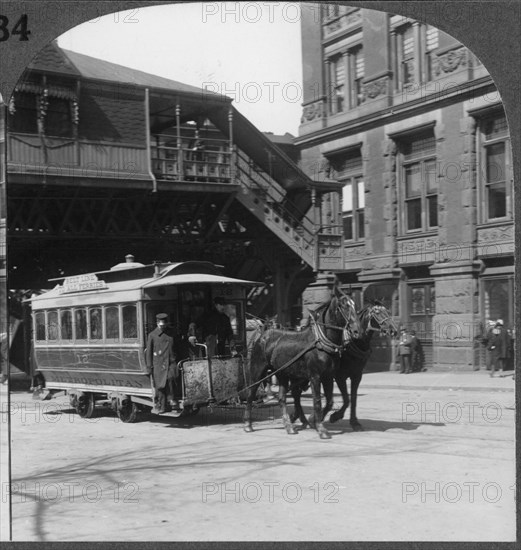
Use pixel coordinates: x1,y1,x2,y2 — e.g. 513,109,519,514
360,370,516,392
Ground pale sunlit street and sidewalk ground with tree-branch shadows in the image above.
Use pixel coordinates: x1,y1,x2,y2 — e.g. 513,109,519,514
0,371,515,542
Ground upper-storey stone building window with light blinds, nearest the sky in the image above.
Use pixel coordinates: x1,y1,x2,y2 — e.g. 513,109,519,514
327,46,365,114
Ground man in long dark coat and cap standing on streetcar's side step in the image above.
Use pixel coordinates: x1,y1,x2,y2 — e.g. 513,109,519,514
145,313,178,413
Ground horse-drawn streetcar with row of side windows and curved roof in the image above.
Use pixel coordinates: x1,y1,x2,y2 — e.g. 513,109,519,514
31,256,259,422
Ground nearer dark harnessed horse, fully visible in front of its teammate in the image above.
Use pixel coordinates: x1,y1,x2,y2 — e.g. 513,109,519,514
244,286,360,439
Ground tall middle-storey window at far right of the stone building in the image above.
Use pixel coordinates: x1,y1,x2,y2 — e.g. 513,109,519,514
479,113,512,223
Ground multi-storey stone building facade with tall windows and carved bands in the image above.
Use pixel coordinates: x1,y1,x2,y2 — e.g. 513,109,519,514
296,4,514,370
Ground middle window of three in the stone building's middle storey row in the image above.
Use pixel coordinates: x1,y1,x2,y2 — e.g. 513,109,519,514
399,130,438,233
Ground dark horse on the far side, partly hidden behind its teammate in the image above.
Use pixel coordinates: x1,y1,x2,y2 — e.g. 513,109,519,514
292,301,398,431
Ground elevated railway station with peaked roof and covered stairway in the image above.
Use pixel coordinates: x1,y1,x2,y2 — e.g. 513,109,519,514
6,42,343,323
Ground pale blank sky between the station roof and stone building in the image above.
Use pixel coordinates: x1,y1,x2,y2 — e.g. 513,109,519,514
58,2,310,136
